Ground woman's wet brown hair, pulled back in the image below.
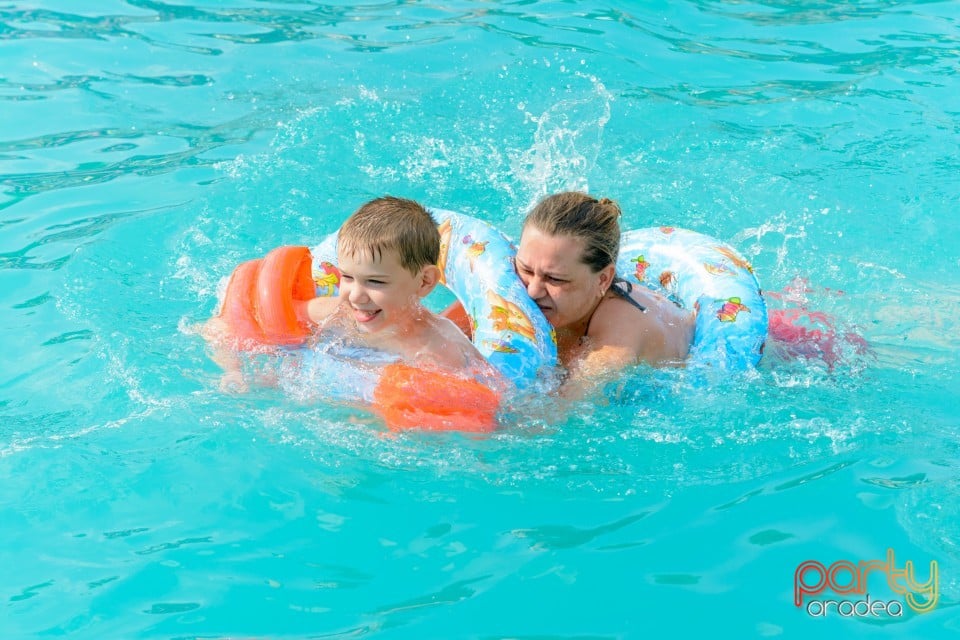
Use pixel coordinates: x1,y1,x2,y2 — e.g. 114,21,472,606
523,191,620,273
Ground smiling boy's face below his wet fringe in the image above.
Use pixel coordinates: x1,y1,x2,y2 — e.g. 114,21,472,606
337,246,436,333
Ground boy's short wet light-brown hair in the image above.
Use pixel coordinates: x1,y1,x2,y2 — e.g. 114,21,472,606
337,196,440,275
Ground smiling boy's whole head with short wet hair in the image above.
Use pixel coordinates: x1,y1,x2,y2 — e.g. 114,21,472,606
337,196,440,333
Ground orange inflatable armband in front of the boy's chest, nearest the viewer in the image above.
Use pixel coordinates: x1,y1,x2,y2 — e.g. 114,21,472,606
373,363,500,432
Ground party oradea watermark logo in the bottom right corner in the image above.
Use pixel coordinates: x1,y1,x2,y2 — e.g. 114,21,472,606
793,549,939,617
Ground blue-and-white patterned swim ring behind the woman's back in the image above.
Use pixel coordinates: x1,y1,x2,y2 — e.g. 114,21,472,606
617,227,767,371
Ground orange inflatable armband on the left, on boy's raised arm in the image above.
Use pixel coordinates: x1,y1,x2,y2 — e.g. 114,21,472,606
220,246,316,348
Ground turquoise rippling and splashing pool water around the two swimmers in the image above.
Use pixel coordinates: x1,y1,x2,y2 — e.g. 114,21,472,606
0,0,960,639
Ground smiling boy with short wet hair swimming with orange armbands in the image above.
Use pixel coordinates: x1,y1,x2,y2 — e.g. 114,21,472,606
204,196,492,391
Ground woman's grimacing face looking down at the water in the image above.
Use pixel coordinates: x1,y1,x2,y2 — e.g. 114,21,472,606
516,226,613,329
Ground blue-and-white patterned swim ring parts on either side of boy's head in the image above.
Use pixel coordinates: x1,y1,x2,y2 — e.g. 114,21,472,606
312,209,557,389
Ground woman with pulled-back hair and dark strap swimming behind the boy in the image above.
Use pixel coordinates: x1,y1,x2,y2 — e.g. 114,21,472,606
444,192,695,395
